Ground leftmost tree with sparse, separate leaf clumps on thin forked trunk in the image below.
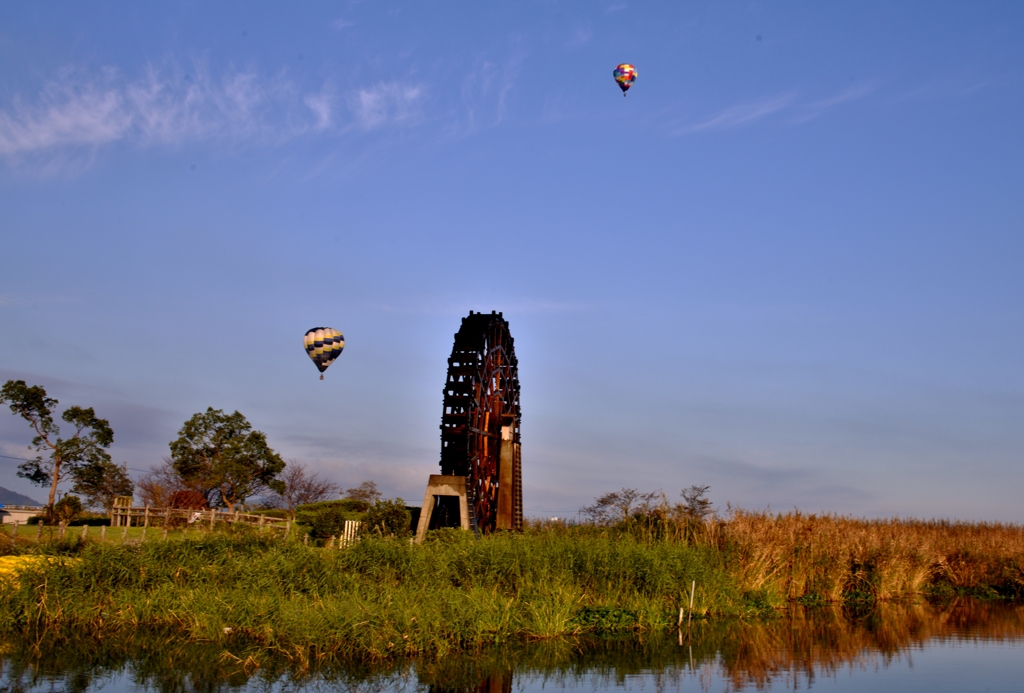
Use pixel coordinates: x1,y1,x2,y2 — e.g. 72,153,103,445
0,380,114,518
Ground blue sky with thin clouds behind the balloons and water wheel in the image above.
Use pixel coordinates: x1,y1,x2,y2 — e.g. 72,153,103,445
0,2,1024,522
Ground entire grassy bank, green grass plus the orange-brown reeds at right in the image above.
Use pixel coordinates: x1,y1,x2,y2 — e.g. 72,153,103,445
0,512,1024,661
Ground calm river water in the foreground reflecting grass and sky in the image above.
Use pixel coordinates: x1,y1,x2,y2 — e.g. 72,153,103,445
0,600,1024,693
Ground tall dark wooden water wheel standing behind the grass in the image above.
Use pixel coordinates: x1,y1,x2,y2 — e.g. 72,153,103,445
440,311,522,533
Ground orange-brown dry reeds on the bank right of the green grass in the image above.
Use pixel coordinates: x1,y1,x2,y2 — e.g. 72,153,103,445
720,511,1024,605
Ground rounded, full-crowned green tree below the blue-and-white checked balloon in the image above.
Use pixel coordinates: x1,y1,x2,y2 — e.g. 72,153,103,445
170,406,285,512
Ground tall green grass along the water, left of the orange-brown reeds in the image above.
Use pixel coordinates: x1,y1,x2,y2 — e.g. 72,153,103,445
0,532,739,659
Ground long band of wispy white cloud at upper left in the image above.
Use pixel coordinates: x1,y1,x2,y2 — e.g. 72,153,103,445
0,62,426,168
